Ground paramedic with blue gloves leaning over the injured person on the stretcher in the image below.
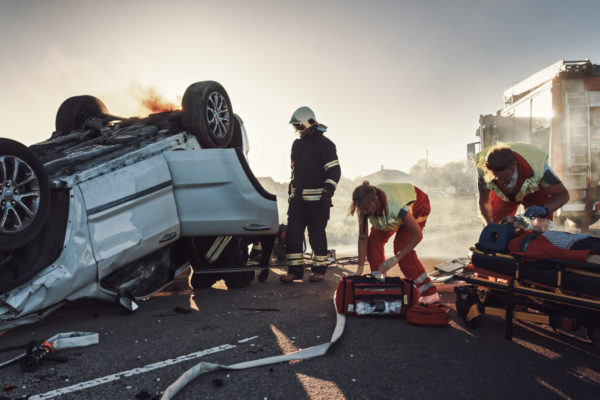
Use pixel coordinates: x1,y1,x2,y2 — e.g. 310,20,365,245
475,143,569,225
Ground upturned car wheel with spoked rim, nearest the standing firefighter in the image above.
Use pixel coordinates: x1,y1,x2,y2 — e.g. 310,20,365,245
181,81,235,147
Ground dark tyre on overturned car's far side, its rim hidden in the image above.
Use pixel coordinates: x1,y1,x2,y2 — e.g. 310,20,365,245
52,95,107,137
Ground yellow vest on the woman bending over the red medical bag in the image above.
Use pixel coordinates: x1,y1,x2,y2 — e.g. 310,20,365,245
369,183,417,232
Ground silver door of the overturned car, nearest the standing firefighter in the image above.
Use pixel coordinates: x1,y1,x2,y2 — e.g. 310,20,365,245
165,149,279,236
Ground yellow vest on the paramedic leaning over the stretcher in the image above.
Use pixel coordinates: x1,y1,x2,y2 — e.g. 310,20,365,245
475,143,548,201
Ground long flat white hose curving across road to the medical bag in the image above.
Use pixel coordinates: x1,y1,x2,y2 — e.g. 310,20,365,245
160,294,346,400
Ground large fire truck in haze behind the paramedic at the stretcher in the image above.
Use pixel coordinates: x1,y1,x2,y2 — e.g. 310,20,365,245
467,59,600,232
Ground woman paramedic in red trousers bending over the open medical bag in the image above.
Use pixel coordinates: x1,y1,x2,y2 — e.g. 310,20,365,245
350,181,440,304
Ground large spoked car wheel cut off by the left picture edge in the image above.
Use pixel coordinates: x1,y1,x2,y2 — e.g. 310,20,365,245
0,139,50,250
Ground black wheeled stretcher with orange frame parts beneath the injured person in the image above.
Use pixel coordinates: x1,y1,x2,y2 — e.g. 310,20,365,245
454,246,600,345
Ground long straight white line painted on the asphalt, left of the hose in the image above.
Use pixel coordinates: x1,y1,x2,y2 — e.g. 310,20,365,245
29,344,236,400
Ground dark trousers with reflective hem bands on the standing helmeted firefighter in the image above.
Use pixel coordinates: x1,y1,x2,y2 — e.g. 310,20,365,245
285,199,329,278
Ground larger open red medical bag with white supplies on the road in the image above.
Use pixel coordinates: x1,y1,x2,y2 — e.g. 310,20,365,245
335,275,419,317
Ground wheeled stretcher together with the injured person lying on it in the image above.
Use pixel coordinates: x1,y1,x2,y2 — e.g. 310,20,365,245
454,216,600,343
